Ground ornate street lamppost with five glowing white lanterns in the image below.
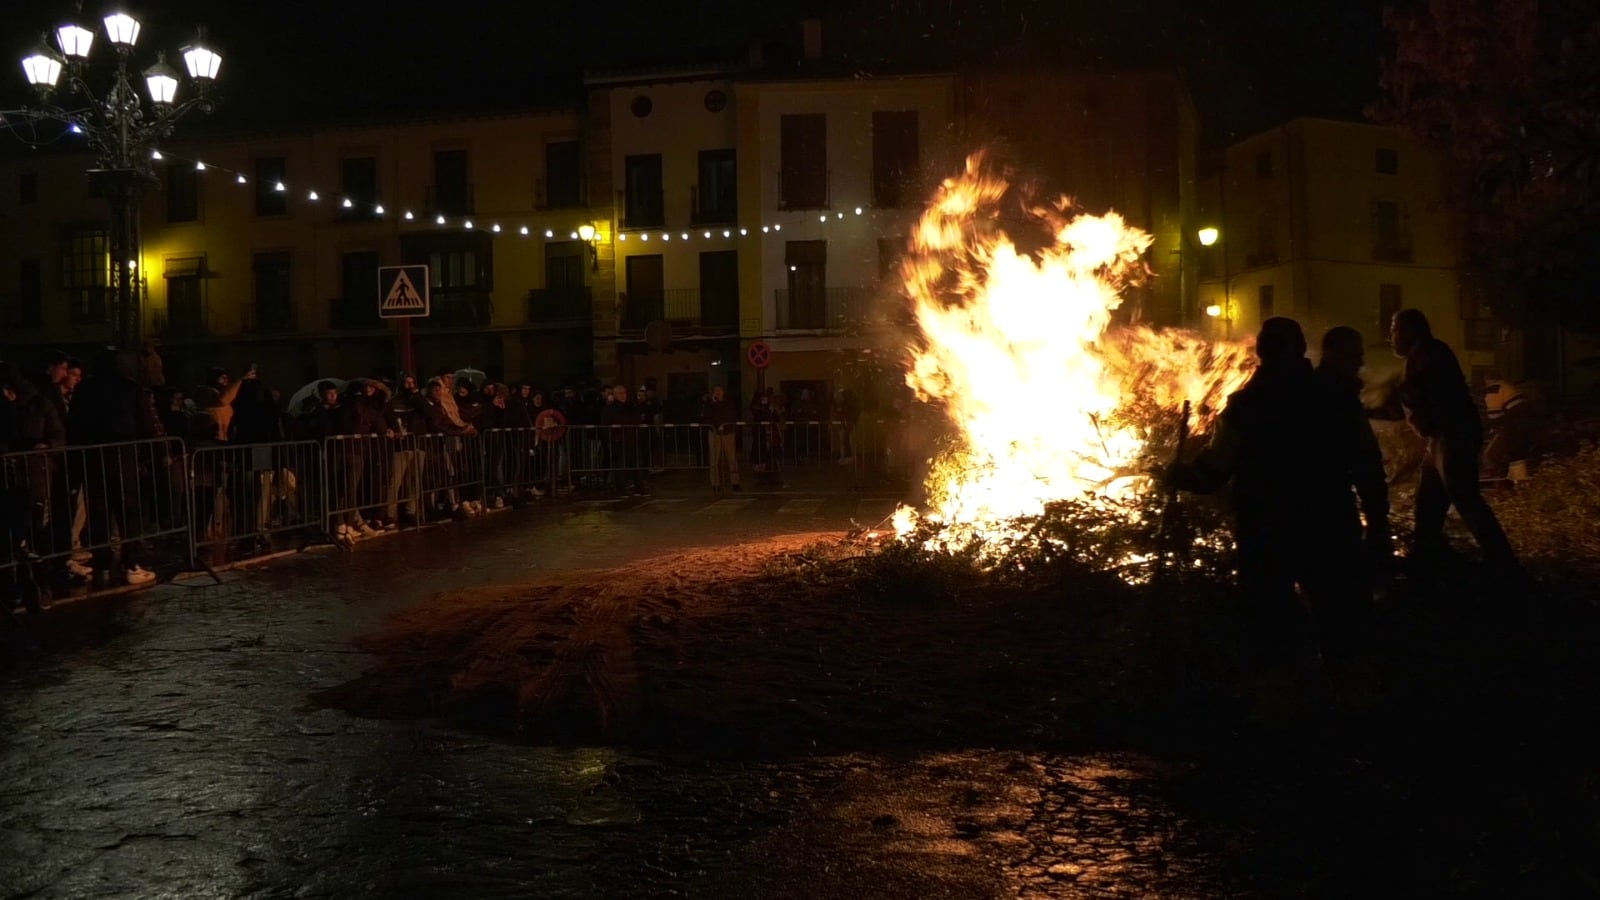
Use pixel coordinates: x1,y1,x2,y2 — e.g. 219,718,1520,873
22,11,222,348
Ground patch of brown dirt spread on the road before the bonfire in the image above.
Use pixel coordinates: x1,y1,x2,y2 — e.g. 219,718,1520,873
315,535,1158,753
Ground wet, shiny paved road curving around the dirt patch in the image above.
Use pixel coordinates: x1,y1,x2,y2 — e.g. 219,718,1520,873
0,495,1230,898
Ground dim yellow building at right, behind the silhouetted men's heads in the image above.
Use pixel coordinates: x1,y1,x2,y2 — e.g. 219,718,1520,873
1198,119,1504,378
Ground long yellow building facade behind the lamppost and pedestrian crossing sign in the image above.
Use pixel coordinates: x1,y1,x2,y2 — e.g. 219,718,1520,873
0,110,594,386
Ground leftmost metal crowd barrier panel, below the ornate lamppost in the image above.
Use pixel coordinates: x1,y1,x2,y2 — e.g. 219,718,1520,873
0,437,189,572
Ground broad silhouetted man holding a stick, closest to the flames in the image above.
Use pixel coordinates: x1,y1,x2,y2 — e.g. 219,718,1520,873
1168,317,1371,668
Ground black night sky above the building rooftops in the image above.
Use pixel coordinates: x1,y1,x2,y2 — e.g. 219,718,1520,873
0,0,1382,144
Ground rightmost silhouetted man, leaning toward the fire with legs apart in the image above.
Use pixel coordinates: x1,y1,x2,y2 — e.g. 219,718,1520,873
1389,309,1517,575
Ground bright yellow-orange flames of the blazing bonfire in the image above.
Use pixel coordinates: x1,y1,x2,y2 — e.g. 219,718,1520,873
893,154,1254,548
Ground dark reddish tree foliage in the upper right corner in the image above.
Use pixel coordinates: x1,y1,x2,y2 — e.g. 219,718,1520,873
1370,0,1600,333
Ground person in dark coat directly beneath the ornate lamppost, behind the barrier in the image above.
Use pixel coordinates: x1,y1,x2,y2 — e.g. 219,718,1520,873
67,351,168,585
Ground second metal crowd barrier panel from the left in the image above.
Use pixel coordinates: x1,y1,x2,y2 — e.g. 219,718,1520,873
189,440,323,565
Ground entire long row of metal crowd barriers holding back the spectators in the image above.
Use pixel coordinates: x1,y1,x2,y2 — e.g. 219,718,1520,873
0,418,926,602
